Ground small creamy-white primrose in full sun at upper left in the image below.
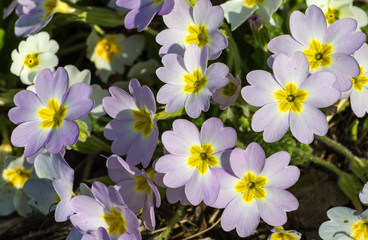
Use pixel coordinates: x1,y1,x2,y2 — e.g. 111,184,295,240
10,32,59,85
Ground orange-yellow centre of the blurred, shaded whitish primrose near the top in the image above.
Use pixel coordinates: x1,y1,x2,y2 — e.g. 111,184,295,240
96,35,122,62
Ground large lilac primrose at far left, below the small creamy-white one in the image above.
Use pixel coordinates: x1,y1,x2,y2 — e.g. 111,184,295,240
9,67,94,157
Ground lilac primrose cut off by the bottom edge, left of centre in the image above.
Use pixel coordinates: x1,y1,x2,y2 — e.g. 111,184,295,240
70,182,141,240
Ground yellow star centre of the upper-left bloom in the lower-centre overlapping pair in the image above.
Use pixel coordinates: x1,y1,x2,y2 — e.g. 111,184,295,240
187,143,219,175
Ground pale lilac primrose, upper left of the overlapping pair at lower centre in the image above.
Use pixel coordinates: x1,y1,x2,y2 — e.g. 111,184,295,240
155,118,236,205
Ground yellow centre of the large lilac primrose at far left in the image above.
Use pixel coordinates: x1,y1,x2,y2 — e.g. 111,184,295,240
37,98,67,129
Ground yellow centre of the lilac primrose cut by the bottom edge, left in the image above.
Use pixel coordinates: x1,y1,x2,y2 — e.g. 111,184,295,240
102,208,126,236
